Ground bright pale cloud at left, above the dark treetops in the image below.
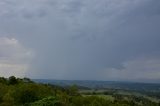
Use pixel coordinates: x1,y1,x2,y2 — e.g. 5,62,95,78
0,37,33,77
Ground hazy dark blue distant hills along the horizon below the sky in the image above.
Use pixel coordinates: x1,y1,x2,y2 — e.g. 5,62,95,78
33,79,160,91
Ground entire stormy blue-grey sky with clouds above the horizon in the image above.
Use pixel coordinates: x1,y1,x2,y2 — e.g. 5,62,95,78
0,0,160,83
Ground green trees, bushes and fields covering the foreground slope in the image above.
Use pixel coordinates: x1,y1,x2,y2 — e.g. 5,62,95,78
0,76,160,106
